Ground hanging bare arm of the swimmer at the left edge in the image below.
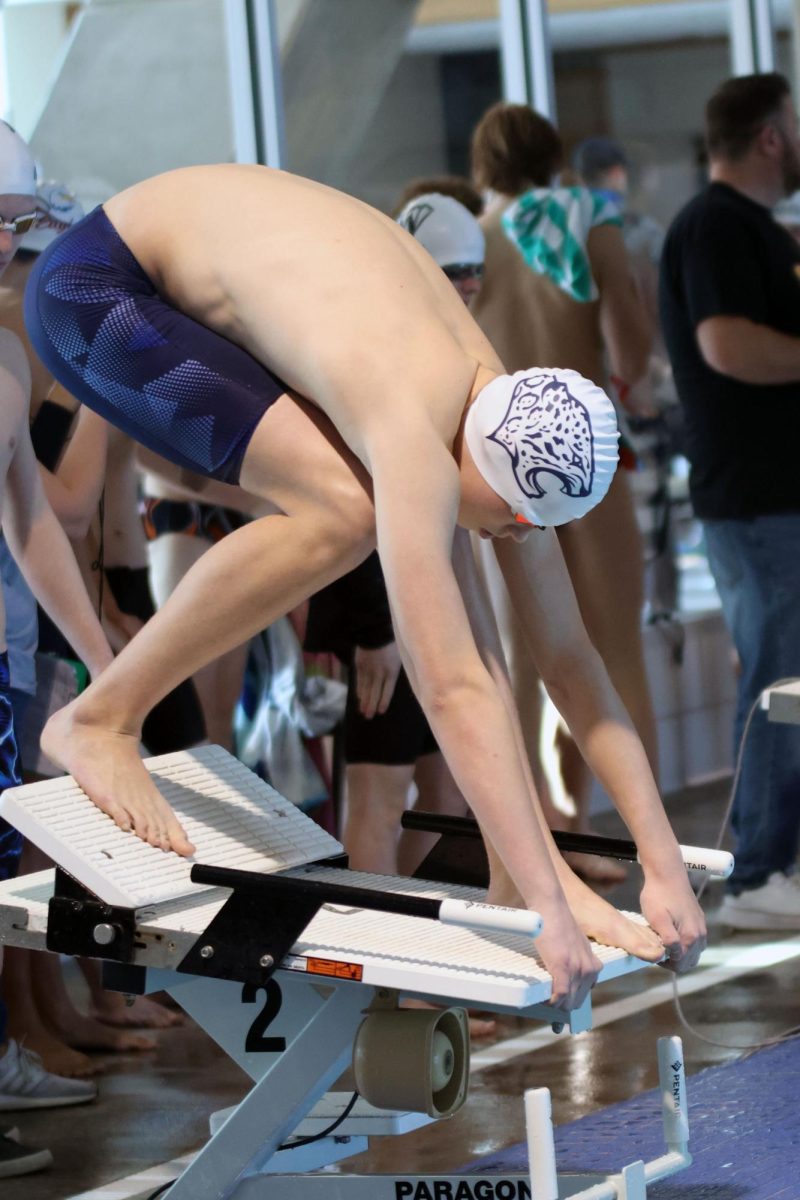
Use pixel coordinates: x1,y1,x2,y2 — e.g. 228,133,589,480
2,421,112,678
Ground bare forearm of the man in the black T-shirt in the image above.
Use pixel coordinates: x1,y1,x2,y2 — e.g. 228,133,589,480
696,317,800,384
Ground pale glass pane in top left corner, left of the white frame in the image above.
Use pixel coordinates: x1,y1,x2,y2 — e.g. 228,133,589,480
0,0,233,206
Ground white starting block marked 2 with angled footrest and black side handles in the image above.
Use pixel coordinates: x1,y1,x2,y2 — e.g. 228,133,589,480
0,746,691,1200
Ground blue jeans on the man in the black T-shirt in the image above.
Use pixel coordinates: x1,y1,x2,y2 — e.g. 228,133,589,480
704,515,800,894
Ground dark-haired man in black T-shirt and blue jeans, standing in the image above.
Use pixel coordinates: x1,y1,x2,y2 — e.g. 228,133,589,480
660,73,800,929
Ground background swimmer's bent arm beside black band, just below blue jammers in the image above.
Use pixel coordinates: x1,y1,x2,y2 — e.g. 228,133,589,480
40,407,108,541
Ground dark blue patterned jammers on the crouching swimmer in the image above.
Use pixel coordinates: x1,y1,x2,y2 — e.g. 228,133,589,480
25,208,292,484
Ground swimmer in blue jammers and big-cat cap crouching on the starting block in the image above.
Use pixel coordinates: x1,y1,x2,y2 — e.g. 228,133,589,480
25,166,705,1008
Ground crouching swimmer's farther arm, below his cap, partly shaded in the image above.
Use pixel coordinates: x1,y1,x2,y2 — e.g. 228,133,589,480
495,530,705,971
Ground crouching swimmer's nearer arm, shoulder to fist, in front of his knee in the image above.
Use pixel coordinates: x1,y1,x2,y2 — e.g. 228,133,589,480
368,413,600,1008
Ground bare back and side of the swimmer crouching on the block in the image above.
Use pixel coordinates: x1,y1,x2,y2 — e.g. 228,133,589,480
106,164,497,451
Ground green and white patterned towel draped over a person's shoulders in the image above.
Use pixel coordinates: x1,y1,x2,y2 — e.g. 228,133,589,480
503,187,622,304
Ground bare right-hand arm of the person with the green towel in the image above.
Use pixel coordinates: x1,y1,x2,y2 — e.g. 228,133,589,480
588,224,654,388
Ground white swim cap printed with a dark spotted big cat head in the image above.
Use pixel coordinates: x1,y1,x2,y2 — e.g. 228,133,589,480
464,367,619,526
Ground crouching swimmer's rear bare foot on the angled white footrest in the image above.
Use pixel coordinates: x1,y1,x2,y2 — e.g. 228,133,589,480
42,696,194,856
